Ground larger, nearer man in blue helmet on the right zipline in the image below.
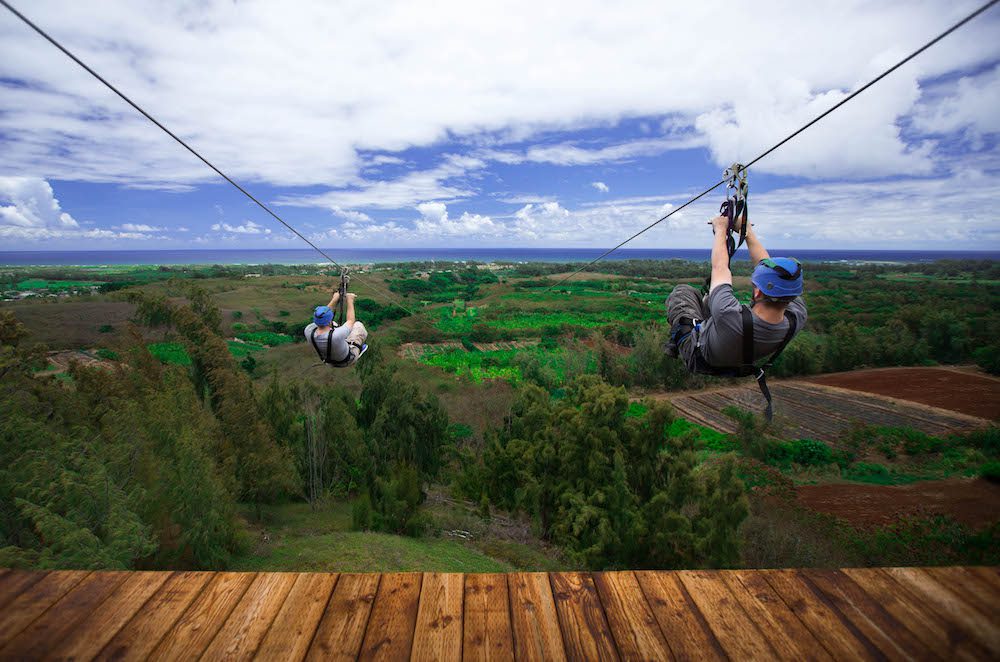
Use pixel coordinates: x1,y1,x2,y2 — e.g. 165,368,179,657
667,216,806,373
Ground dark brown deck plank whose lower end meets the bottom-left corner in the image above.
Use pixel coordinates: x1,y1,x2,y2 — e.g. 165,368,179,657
0,572,128,660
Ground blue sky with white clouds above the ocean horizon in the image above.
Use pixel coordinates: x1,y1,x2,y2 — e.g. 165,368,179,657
0,0,1000,250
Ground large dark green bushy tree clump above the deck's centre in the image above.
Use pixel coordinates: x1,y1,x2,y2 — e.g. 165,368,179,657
476,377,747,568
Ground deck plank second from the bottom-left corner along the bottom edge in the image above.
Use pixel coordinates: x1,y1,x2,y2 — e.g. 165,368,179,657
49,572,171,660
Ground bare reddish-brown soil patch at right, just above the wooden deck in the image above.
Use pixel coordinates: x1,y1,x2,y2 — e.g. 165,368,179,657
796,478,1000,528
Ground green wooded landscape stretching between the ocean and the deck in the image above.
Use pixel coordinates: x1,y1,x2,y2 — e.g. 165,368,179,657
0,261,1000,569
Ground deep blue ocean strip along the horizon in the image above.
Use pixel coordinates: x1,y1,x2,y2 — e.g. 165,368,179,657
0,248,1000,266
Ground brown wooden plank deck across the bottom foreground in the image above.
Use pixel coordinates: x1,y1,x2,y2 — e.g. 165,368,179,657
0,567,1000,660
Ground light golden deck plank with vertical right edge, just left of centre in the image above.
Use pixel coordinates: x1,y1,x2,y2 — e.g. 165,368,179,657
410,572,464,660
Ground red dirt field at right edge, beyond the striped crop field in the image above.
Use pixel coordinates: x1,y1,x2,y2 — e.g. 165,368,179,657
807,368,1000,420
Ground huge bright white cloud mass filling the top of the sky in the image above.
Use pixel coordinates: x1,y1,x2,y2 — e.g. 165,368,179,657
0,0,1000,192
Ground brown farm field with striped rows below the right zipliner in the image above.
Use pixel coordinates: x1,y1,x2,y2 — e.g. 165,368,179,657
667,380,989,442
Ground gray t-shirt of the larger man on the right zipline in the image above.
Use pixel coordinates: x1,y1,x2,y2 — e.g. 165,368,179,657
700,285,807,368
